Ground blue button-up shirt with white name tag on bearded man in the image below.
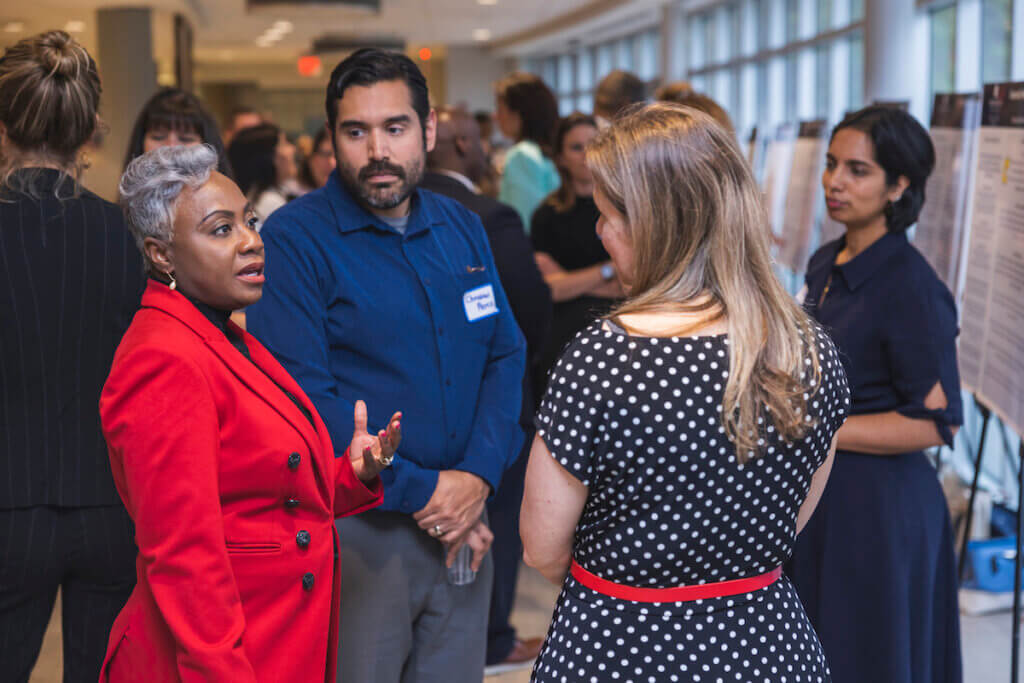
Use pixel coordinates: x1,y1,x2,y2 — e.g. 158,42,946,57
247,172,525,513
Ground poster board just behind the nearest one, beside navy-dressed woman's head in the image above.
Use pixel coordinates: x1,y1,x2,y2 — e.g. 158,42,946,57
913,93,981,295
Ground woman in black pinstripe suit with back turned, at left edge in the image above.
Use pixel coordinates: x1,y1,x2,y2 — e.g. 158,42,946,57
0,31,145,683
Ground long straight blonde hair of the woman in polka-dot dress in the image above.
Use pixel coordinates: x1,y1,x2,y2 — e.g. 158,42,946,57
587,102,820,463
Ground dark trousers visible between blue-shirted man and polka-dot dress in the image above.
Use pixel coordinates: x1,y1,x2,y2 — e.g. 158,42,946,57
487,430,534,666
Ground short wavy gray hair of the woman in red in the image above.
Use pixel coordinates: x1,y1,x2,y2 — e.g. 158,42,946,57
118,144,217,268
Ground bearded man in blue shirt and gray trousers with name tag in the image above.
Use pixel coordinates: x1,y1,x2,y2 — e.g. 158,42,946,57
248,49,525,683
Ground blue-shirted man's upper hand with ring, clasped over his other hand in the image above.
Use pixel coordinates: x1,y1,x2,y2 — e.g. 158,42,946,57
413,470,490,550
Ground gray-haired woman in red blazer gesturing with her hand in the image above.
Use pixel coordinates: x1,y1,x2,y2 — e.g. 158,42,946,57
99,141,400,683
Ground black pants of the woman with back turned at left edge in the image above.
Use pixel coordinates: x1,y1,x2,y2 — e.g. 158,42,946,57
0,506,137,683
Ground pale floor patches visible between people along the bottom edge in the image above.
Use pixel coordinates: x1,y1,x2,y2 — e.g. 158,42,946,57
30,567,1024,683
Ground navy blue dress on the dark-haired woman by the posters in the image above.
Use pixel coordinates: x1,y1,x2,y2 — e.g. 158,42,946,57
785,232,963,683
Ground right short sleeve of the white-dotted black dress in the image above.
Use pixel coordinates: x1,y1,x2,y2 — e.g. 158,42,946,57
803,323,850,469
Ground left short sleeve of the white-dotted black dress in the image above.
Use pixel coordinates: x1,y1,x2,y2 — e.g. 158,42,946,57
536,326,611,486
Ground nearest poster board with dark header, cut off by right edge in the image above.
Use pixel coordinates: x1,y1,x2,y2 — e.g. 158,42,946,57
959,78,1024,433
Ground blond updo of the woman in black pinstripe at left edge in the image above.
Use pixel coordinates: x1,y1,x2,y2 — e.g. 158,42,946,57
0,31,101,189
